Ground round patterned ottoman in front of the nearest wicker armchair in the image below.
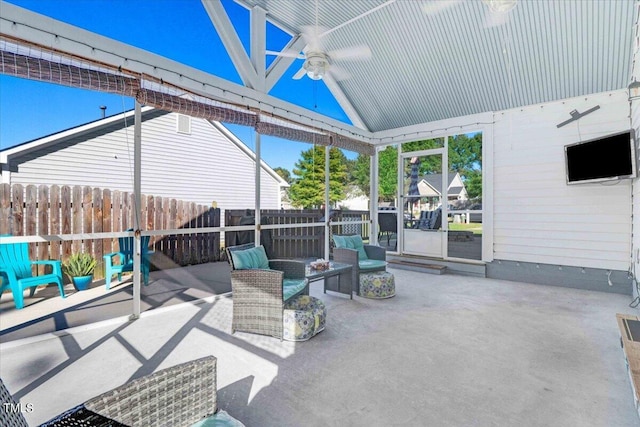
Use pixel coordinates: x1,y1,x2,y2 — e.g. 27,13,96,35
282,295,327,341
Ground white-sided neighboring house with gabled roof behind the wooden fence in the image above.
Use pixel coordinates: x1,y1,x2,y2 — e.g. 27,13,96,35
0,107,288,222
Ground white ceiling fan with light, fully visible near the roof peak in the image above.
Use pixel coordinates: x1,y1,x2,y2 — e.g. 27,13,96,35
266,0,395,81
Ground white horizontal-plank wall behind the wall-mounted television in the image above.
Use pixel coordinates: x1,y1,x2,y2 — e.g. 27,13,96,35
493,91,632,270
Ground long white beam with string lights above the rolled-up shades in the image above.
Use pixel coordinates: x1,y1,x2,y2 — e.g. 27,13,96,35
0,0,373,142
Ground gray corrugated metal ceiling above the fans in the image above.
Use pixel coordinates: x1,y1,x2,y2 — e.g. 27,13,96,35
240,0,637,131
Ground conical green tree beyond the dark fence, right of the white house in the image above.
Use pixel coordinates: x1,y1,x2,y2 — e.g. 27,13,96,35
289,146,347,208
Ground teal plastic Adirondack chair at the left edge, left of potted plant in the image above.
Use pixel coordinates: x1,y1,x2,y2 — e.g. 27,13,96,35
0,235,65,309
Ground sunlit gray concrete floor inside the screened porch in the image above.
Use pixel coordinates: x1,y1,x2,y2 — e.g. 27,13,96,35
0,269,640,426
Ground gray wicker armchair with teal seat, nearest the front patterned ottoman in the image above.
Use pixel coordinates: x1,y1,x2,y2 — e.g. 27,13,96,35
226,245,309,340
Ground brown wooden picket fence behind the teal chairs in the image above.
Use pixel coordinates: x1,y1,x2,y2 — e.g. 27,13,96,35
0,184,220,275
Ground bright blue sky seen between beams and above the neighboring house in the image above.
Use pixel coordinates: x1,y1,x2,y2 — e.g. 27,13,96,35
0,0,355,174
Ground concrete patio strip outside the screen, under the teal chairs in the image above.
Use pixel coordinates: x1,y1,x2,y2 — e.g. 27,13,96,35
0,262,231,343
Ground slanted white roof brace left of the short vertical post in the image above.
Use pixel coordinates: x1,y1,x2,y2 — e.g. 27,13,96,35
202,0,259,89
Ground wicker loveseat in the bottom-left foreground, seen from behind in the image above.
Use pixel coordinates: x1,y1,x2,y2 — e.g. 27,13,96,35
0,356,243,427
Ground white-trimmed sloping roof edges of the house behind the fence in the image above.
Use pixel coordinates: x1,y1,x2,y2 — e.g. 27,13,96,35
0,107,289,187
